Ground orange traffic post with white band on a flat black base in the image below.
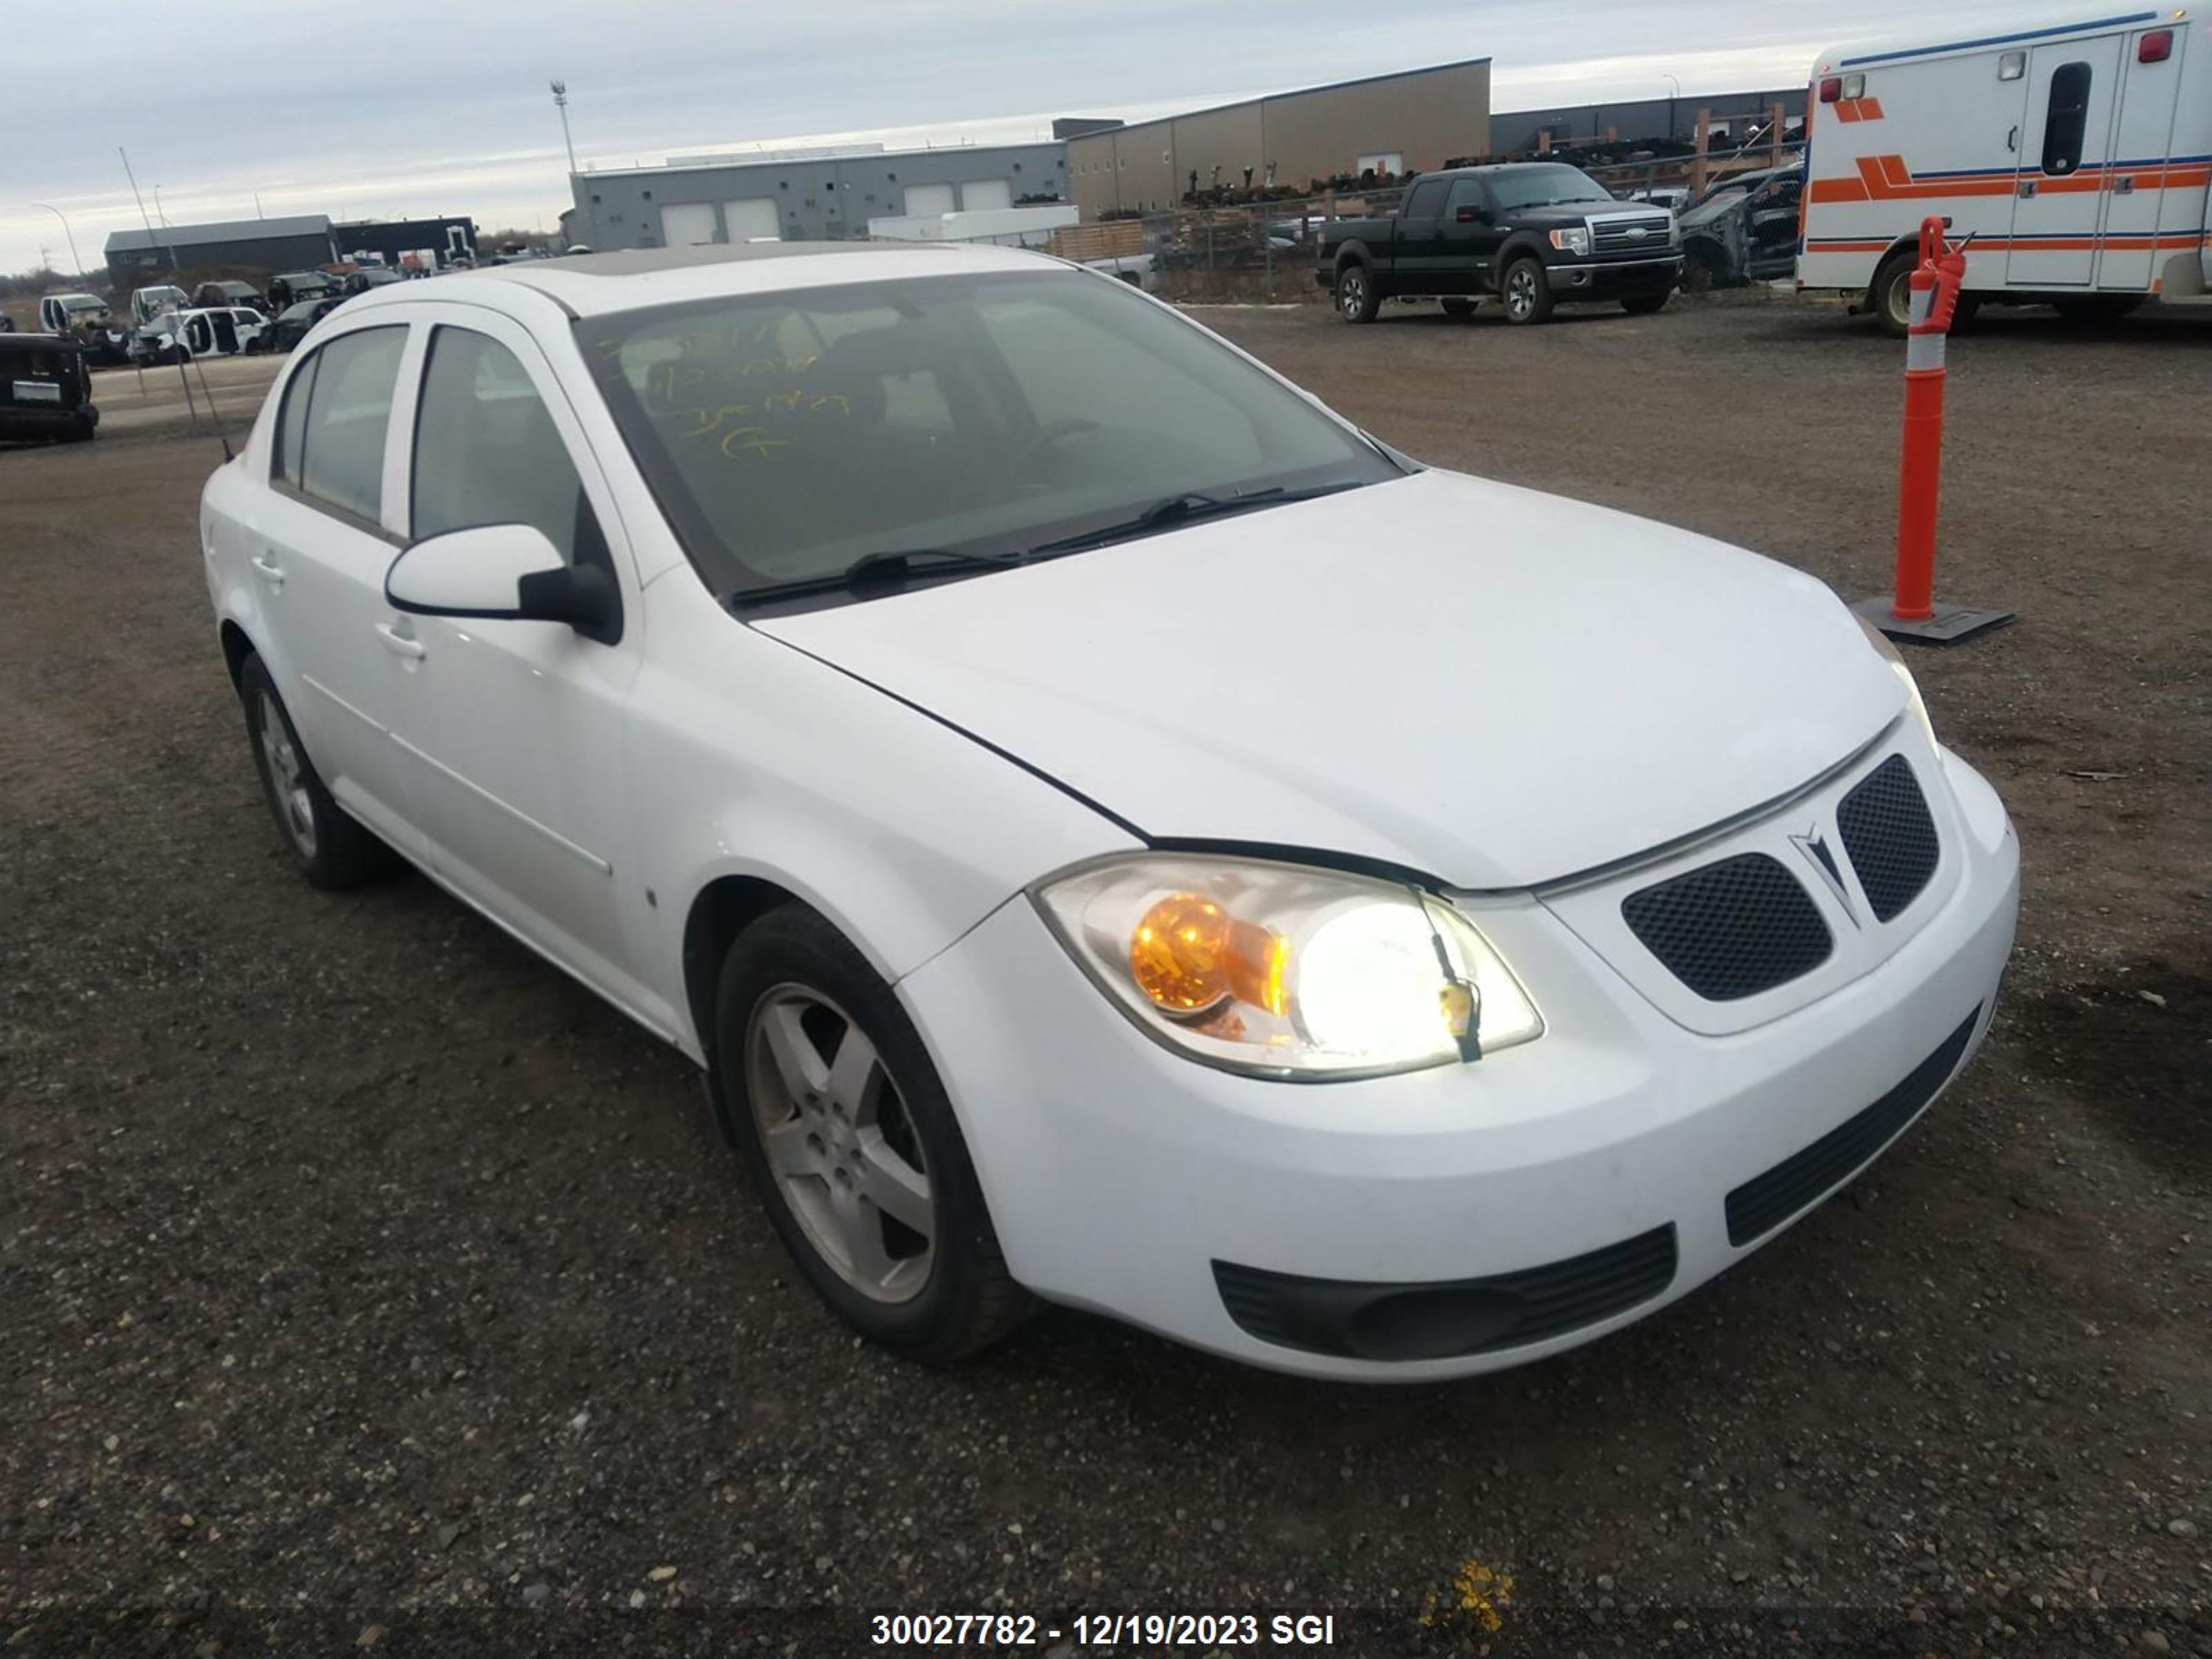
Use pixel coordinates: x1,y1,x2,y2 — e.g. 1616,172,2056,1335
1851,219,2013,646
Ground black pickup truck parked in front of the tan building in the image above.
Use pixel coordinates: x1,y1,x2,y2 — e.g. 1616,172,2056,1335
1314,162,1681,323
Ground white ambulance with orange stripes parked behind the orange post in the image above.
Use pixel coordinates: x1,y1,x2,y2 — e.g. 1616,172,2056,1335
1799,11,2212,334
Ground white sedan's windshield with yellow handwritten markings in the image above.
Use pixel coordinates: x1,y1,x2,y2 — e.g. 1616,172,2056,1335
577,268,1400,597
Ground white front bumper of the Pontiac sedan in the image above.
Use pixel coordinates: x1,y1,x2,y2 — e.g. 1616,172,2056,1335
898,754,2020,1380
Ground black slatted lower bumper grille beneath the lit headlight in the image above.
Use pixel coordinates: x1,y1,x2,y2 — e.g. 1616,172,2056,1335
1215,1224,1677,1360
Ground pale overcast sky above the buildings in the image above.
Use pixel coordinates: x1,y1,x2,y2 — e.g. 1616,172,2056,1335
0,0,2022,270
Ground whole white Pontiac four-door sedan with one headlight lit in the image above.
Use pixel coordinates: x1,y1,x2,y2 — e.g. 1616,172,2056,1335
201,243,2020,1380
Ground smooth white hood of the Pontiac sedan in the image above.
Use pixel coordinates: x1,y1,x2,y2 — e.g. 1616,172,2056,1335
756,471,1904,889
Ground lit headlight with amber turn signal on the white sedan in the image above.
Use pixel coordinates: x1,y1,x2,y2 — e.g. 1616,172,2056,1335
1033,854,1544,1077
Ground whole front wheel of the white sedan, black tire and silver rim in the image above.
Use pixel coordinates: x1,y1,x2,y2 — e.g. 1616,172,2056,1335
715,905,1031,1365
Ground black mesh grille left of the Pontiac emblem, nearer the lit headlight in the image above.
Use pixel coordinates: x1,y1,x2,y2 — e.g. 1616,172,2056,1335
1622,852,1836,1002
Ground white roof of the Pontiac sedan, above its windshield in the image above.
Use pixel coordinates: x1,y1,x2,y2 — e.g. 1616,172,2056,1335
384,241,1064,317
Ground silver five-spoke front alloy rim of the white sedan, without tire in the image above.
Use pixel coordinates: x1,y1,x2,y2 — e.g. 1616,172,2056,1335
745,984,938,1303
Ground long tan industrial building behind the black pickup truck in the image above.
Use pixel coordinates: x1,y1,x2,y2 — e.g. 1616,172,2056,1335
1066,57,1491,219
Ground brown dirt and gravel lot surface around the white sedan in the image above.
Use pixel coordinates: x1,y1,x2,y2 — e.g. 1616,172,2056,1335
0,297,2212,1655
